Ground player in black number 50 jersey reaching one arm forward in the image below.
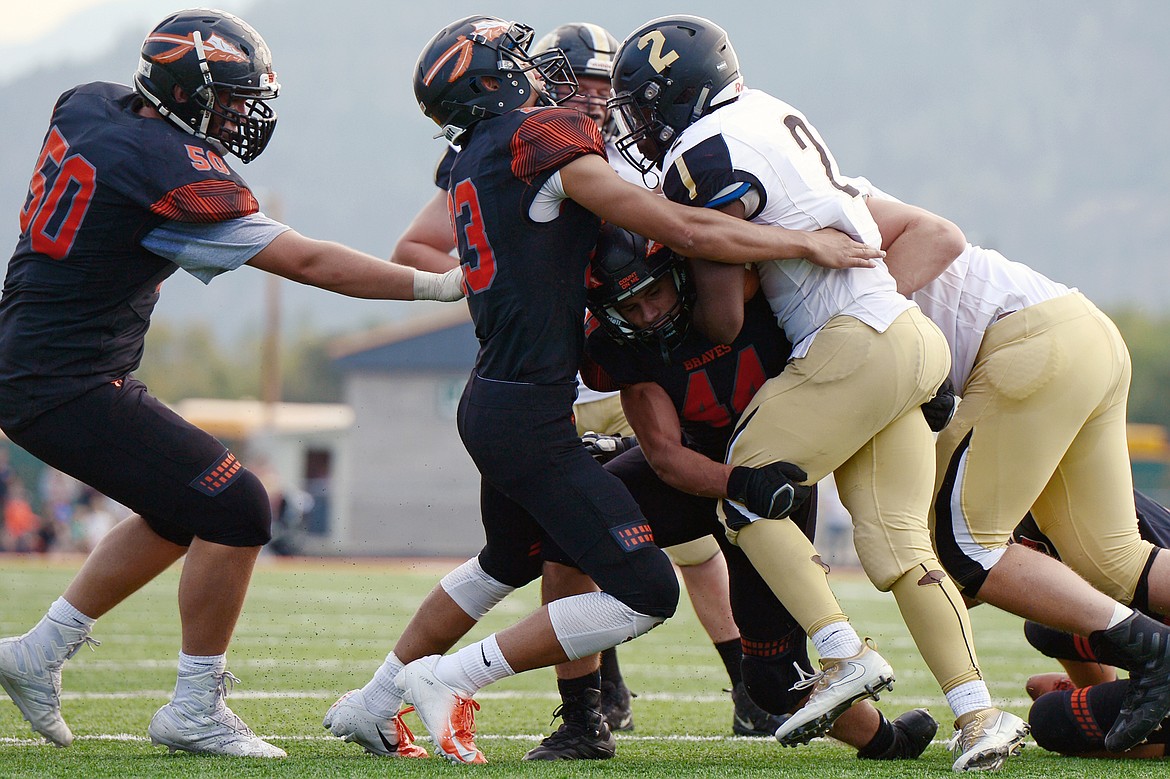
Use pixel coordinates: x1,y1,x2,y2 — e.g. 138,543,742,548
0,9,462,758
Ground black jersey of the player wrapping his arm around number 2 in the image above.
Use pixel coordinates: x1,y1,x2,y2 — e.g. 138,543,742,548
447,108,605,384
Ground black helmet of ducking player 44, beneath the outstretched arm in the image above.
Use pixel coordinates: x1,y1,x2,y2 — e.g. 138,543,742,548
586,222,695,364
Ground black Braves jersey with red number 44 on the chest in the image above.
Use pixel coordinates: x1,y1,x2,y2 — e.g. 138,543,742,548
581,292,792,461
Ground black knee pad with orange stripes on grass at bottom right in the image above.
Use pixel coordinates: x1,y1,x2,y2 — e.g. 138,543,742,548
1028,682,1128,754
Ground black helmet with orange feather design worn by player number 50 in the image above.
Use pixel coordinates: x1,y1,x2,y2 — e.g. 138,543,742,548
135,8,281,163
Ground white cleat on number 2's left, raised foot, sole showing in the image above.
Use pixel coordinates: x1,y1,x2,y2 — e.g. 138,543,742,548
776,639,894,746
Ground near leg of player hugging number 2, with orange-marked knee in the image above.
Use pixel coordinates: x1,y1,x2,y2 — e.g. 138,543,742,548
398,377,679,763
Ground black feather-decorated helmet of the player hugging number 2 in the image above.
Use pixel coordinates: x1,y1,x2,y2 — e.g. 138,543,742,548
414,15,577,143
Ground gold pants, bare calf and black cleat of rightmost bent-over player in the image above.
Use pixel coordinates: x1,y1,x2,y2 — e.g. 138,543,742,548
936,294,1170,750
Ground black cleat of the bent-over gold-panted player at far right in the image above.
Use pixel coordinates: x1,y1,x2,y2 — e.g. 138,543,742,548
1093,612,1170,752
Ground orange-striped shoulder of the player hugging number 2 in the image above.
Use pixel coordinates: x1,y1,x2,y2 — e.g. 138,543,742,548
511,109,605,184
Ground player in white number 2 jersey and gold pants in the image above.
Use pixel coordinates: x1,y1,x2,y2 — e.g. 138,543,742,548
611,15,1027,770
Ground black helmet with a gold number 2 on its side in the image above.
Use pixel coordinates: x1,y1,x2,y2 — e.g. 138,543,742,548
610,15,743,173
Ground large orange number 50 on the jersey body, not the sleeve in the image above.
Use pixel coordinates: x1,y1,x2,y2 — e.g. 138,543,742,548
20,126,97,260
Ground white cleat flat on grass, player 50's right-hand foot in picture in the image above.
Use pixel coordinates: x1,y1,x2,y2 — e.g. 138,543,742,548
146,671,287,758
